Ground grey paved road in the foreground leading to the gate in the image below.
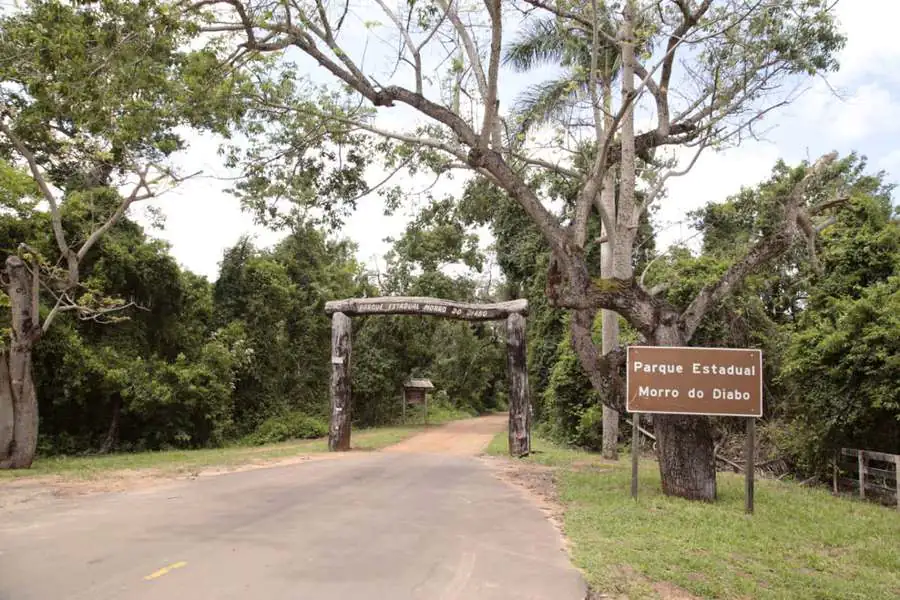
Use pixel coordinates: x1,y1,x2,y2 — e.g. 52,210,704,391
0,418,585,600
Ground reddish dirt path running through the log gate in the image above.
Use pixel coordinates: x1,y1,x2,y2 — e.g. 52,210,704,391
384,414,509,456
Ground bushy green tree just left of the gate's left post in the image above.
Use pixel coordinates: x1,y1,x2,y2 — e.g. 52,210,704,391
214,223,362,435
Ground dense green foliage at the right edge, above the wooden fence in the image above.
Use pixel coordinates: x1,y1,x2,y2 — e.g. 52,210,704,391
778,196,900,473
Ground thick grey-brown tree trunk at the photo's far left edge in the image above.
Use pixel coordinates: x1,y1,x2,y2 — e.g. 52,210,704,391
0,256,39,469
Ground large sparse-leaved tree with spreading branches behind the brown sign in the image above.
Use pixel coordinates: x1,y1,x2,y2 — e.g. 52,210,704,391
199,0,843,500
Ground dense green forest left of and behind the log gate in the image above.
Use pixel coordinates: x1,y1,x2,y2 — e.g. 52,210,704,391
2,204,505,454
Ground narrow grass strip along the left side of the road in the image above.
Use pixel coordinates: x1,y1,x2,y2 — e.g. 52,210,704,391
0,426,421,483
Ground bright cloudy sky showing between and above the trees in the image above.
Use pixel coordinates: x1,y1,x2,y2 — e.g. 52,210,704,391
132,0,900,279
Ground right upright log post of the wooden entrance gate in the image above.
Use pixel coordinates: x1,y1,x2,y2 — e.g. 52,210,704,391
506,314,531,457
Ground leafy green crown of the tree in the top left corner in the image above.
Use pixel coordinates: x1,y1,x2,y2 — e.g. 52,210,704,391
0,0,242,183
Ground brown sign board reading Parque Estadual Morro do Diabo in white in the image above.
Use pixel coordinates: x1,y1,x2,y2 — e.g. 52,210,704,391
625,346,762,417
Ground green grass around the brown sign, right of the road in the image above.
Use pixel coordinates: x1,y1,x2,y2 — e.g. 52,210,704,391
488,434,900,600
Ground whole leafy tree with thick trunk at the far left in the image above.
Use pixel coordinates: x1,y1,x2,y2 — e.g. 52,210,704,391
0,0,239,468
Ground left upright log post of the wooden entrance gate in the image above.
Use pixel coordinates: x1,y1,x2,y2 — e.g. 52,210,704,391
328,312,353,452
